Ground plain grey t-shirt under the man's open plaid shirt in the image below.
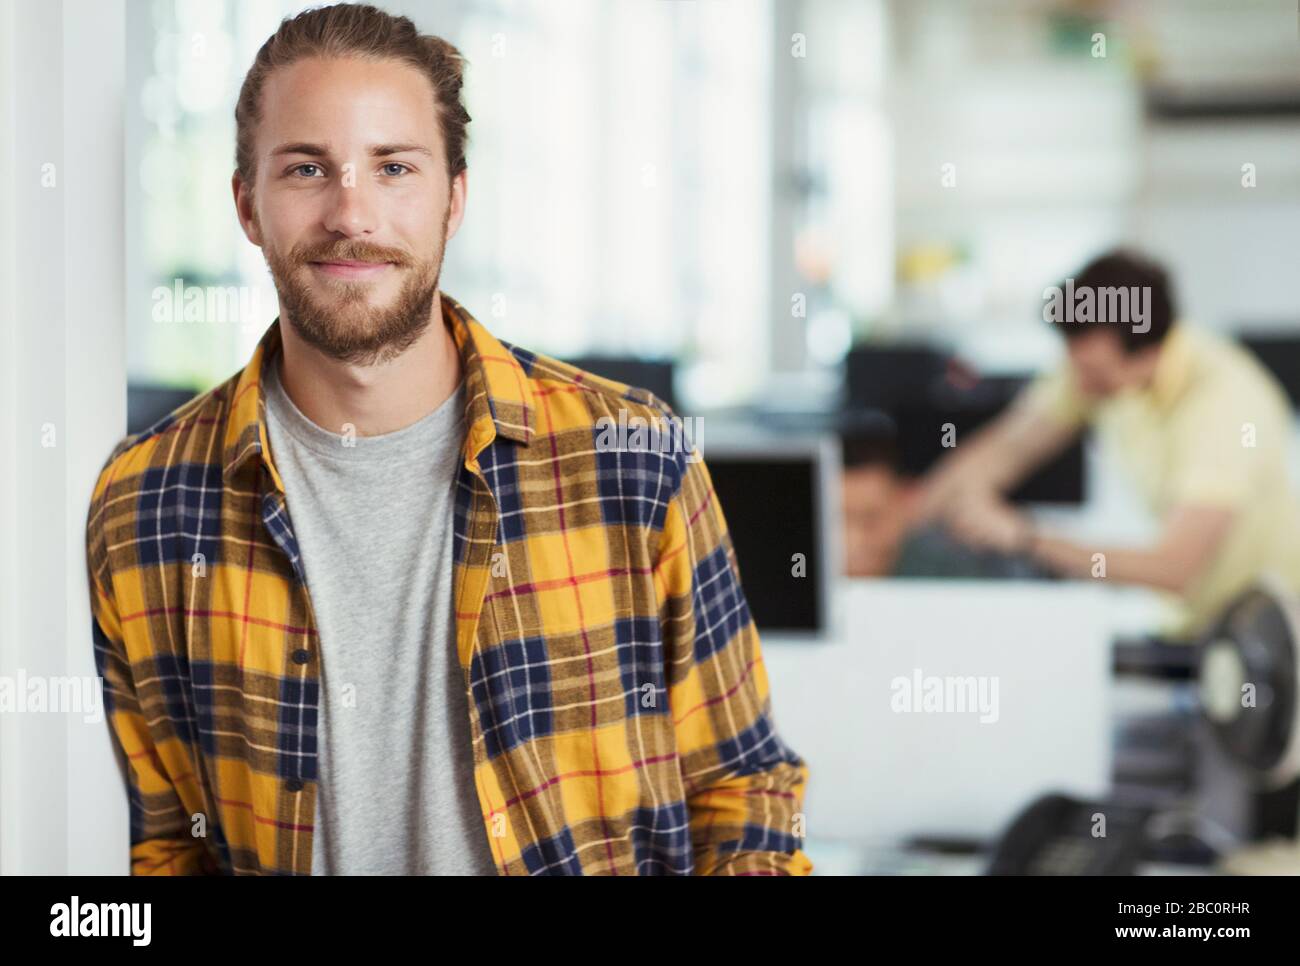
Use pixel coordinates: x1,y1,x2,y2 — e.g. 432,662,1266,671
265,355,497,875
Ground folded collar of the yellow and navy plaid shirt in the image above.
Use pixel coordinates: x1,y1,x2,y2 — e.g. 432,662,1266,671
222,293,534,491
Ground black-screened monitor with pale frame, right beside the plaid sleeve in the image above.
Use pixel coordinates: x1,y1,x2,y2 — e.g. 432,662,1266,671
703,436,842,638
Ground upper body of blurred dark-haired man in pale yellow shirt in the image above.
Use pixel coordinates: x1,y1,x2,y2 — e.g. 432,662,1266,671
918,251,1300,638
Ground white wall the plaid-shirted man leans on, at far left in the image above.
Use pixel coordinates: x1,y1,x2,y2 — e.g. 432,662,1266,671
0,0,129,874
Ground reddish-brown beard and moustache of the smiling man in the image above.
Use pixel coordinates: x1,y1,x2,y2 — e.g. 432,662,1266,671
263,211,450,365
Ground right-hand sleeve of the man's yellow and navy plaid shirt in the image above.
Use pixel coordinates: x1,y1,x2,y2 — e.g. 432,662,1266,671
655,451,813,875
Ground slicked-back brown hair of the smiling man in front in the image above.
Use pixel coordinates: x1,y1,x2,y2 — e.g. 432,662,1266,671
235,4,471,186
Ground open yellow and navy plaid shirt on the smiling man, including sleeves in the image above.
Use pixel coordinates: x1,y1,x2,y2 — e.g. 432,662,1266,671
87,295,811,875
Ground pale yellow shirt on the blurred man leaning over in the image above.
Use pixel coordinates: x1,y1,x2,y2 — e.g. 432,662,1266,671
1026,325,1300,636
